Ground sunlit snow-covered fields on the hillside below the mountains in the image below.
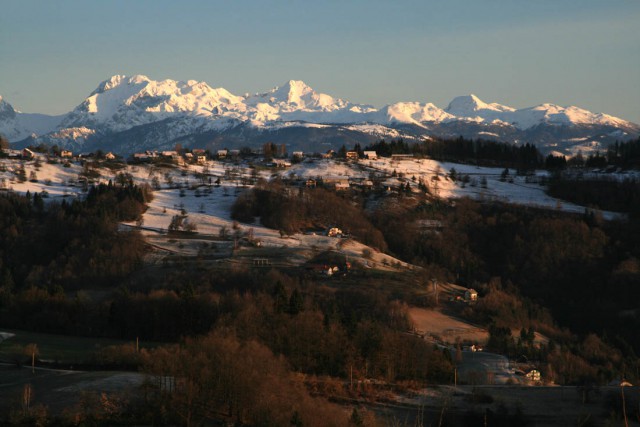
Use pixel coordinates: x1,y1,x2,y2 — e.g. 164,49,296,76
0,157,619,247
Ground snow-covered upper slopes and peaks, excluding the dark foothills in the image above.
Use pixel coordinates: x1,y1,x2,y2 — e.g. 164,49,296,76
0,75,640,155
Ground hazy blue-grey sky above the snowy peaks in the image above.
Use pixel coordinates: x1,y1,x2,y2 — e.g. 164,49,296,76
0,0,640,123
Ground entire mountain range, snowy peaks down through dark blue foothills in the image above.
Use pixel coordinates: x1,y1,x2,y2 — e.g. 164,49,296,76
0,75,640,156
